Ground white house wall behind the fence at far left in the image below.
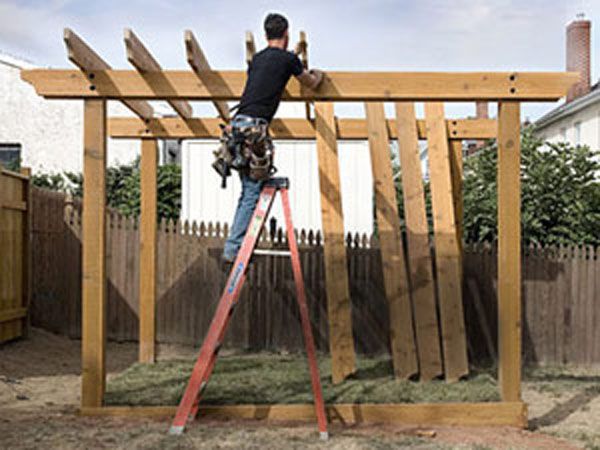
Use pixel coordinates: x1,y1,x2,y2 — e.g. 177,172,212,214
0,53,140,172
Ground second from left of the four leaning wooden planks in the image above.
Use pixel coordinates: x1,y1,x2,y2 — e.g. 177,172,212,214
365,103,419,379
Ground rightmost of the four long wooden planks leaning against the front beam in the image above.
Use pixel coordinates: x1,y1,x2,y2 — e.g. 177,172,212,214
425,103,469,381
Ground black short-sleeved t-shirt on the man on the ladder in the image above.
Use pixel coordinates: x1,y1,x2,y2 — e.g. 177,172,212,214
237,47,304,122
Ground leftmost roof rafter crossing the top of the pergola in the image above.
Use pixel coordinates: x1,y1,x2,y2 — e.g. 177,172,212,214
63,28,154,120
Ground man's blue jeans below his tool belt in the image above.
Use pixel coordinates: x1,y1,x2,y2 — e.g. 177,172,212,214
223,173,264,261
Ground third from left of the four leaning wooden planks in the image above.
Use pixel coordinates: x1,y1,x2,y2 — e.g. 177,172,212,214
396,103,442,380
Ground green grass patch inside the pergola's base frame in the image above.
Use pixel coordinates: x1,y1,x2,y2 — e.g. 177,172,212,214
105,354,499,406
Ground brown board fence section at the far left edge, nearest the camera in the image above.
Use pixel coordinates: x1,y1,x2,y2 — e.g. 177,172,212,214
0,165,31,343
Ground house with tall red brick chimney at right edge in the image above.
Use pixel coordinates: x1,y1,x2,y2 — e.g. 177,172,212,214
534,16,600,150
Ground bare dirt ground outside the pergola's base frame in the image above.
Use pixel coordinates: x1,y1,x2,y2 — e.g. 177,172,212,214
0,329,600,450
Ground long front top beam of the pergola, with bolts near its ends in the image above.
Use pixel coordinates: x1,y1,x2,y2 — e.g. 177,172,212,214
21,69,579,101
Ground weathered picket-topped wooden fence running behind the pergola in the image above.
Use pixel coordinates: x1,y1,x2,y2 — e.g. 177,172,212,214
32,190,600,364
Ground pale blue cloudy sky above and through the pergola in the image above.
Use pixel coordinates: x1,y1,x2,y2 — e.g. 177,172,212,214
0,0,600,120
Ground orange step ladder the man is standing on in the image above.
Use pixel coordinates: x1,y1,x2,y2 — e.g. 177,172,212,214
169,178,329,439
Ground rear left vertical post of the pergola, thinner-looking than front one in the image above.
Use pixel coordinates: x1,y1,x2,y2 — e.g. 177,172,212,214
138,139,158,363
